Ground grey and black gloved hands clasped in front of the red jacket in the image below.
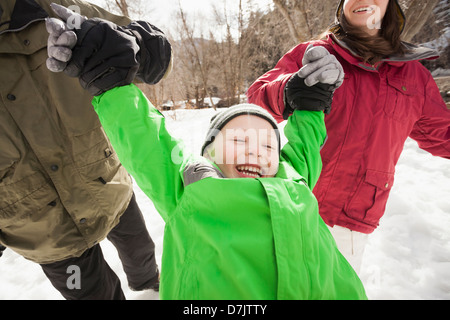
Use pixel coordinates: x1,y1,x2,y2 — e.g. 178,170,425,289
283,45,344,119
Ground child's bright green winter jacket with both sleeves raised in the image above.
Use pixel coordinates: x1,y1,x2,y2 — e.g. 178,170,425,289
93,85,366,299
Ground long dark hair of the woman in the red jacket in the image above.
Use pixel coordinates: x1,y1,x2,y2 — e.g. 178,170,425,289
328,0,406,64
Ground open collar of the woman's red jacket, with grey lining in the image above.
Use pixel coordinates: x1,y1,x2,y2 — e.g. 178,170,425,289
327,33,439,71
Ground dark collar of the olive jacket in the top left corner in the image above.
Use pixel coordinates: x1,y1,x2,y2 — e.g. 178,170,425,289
0,0,48,34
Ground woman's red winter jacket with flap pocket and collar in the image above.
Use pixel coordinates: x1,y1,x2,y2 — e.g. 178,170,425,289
247,35,450,233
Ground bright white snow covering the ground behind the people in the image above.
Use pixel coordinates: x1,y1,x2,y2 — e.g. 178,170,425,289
0,109,450,300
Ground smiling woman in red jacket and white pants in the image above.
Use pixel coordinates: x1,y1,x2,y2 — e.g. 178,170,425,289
247,0,450,271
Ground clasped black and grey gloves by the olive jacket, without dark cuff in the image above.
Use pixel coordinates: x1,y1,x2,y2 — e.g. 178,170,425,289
46,3,140,96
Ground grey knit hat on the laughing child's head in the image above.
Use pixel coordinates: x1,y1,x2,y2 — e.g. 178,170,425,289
201,103,281,155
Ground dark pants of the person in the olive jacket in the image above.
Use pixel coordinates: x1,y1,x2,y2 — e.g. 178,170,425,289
41,195,159,300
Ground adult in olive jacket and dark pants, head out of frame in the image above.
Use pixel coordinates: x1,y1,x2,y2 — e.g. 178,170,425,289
0,0,171,299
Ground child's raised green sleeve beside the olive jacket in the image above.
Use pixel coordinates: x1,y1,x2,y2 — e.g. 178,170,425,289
92,84,187,220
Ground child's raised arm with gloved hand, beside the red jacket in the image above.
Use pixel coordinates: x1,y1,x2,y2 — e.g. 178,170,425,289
281,46,344,190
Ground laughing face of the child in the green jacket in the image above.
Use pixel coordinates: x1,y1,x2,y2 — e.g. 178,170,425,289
209,115,279,178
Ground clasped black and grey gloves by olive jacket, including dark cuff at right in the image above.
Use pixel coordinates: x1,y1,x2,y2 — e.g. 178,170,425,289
47,4,172,95
